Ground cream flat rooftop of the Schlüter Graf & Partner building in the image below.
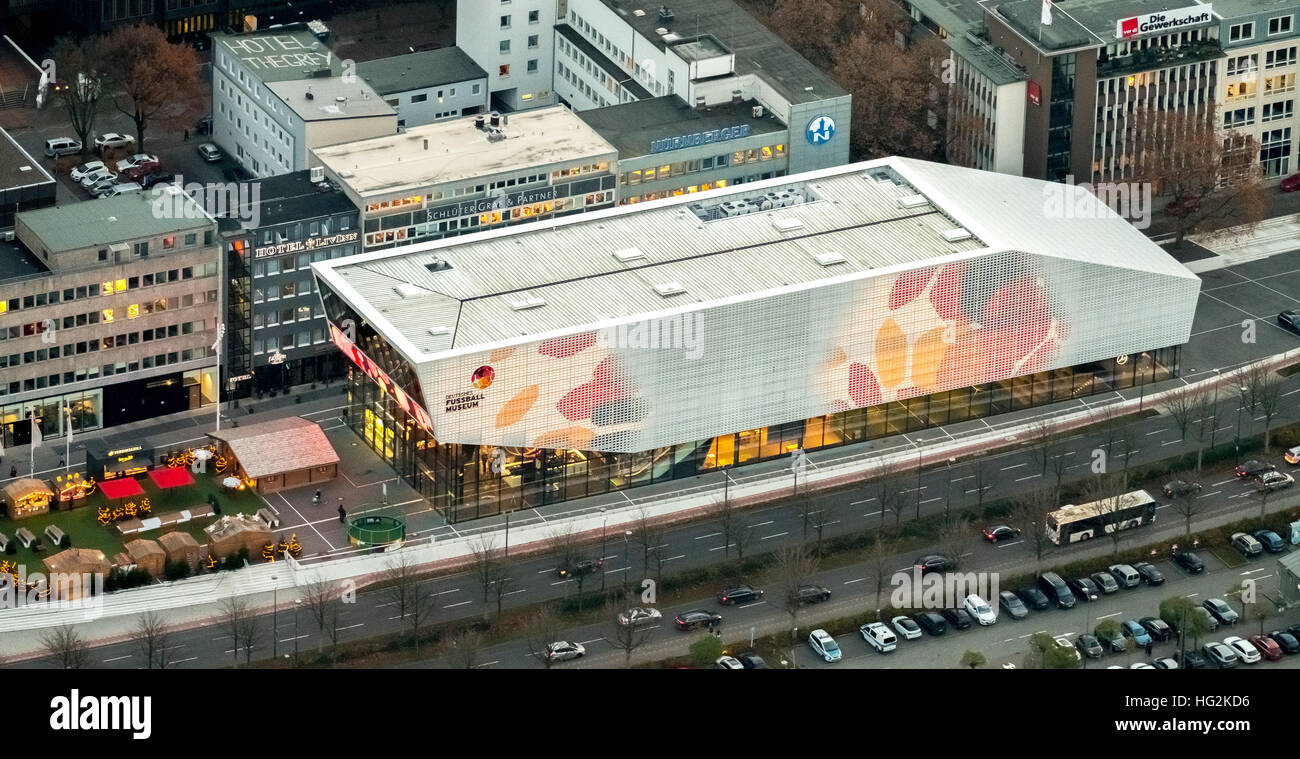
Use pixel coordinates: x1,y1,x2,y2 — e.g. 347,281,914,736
313,105,615,198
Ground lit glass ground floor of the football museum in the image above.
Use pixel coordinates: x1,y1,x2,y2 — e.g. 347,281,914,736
345,347,1179,522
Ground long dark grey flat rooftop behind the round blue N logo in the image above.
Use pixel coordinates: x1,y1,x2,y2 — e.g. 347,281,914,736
603,0,848,104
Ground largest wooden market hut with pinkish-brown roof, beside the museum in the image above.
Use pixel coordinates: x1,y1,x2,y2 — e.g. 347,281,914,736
208,416,338,493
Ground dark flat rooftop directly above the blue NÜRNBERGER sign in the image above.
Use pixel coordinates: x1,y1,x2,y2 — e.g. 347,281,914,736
577,95,785,160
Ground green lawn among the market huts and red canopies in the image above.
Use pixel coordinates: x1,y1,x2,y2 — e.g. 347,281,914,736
0,474,264,572
